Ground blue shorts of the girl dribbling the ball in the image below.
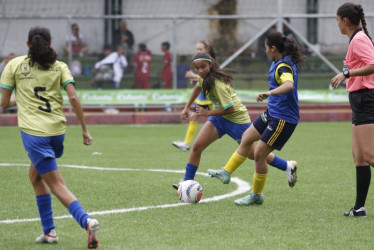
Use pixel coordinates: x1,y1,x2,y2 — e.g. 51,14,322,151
208,116,251,142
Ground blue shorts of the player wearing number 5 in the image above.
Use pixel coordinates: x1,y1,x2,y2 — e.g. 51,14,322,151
21,131,65,174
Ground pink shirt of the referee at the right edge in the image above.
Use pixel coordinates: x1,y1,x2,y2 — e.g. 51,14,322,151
344,31,374,92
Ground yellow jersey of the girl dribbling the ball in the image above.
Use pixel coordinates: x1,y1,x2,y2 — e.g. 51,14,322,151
196,78,251,124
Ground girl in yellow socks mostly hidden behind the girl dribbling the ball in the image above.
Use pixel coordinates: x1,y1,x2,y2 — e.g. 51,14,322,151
172,40,216,152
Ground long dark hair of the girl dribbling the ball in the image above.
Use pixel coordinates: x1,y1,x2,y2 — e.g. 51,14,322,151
192,52,234,96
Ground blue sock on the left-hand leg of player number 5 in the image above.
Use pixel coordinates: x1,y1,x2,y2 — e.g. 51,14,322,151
36,194,56,234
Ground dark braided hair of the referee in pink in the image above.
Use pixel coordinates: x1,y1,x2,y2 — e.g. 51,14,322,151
336,3,374,44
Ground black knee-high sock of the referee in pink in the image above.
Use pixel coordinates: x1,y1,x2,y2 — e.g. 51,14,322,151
354,166,371,210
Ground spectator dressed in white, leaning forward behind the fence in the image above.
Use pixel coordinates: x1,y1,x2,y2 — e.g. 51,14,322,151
95,45,127,89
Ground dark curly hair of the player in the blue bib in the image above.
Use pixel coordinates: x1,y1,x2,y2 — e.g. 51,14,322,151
266,32,305,70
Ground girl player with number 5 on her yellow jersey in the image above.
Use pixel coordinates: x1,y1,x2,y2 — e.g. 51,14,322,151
0,27,99,248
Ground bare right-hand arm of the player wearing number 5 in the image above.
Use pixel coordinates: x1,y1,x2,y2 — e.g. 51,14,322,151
65,83,93,145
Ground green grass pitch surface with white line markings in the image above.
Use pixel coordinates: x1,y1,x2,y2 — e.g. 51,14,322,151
0,122,374,249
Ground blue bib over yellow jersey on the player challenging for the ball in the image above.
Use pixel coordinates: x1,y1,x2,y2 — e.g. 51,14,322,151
268,56,300,124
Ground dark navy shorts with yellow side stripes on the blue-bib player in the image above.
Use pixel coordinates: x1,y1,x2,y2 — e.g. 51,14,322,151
253,110,297,150
